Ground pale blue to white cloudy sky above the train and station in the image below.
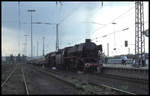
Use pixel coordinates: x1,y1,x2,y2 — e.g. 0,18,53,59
1,1,149,56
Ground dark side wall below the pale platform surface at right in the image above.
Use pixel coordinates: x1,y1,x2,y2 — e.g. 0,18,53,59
102,66,149,81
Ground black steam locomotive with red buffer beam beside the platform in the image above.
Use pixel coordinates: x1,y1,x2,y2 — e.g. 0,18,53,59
45,39,102,72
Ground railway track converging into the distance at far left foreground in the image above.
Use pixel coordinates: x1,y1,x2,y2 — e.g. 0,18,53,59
1,65,29,95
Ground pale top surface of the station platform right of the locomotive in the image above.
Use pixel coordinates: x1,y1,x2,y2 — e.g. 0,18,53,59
103,64,149,70
